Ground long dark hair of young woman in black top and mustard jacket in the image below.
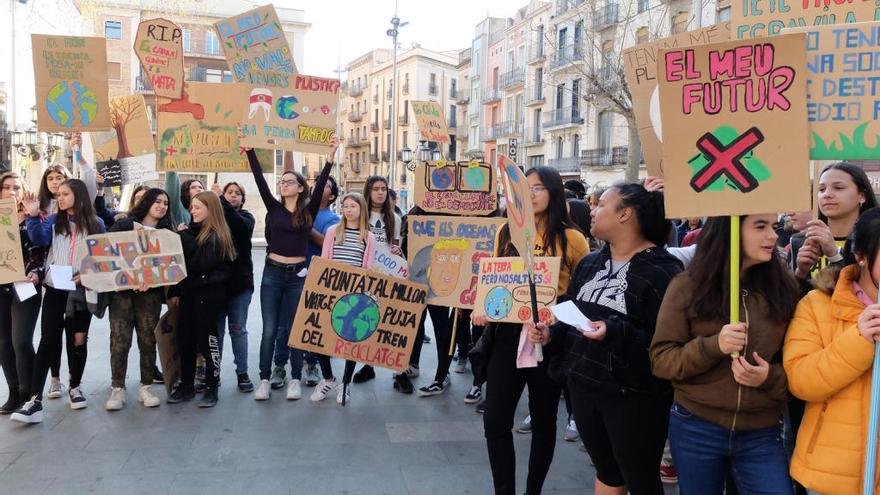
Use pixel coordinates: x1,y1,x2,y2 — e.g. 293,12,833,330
498,166,577,256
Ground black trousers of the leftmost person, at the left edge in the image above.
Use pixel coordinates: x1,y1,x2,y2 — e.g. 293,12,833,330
0,288,42,399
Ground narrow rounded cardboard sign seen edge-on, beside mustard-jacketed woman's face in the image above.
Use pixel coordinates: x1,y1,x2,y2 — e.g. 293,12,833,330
498,155,537,269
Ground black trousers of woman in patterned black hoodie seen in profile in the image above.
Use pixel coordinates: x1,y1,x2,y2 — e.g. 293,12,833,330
568,379,672,495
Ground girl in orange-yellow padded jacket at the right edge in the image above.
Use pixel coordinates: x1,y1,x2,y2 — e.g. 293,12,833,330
783,208,880,495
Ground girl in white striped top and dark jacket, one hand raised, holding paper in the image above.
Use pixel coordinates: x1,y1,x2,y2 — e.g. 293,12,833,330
12,179,104,423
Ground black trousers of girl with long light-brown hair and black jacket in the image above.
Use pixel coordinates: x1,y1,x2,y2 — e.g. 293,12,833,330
177,284,228,388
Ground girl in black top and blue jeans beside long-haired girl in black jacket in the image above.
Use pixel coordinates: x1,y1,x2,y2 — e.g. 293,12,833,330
211,182,256,393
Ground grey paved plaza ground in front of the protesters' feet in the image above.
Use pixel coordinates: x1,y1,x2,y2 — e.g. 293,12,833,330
0,254,680,495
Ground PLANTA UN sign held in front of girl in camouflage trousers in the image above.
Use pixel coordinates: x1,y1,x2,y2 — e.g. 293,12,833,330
79,229,186,292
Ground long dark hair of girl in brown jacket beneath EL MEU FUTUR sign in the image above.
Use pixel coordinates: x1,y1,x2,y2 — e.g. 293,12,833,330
686,217,800,323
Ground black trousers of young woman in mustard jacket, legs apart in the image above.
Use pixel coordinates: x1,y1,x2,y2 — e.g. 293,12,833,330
483,324,560,495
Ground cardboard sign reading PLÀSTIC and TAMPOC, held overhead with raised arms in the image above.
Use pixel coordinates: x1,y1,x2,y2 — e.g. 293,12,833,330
235,74,339,153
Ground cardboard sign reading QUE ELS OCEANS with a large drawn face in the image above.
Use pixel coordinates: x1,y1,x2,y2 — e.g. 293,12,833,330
407,216,505,308
